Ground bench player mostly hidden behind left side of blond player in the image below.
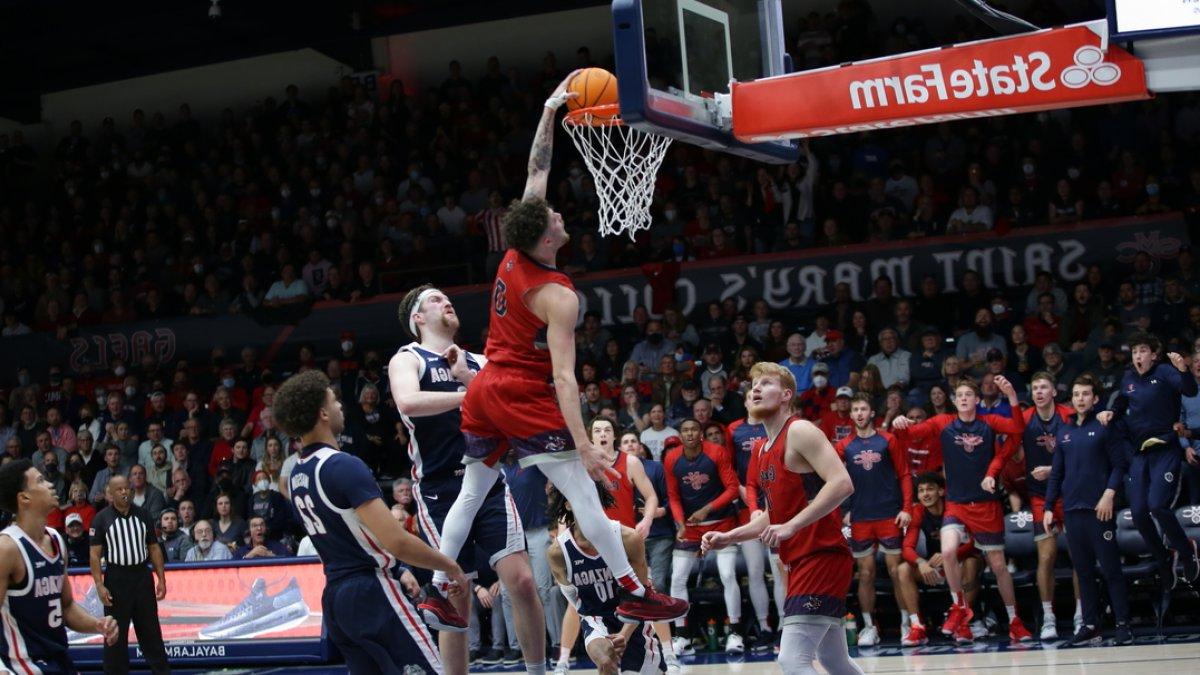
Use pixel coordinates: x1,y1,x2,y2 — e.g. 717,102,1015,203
725,389,776,651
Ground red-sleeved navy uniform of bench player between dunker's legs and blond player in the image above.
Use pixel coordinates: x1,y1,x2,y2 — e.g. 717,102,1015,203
662,441,738,550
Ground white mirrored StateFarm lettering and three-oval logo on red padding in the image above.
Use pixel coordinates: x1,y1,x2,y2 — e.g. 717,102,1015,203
850,44,1121,110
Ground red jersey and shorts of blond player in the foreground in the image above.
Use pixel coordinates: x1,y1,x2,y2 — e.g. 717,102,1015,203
756,416,854,625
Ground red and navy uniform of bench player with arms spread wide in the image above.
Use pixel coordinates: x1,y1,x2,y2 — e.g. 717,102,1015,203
904,413,1025,551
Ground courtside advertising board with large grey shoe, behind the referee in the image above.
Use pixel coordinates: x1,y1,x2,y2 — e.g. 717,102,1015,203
67,558,328,665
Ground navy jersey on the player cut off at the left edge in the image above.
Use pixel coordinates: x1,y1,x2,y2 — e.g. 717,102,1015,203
0,525,74,673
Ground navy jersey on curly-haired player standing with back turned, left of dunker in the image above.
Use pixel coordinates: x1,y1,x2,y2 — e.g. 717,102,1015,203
288,443,396,584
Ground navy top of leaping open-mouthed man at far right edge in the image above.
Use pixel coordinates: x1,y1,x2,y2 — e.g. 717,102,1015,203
1112,363,1196,452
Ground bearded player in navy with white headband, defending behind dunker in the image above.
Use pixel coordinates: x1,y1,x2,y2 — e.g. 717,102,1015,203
388,286,546,674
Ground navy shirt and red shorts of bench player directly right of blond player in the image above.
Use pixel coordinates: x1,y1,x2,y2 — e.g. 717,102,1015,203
835,431,912,557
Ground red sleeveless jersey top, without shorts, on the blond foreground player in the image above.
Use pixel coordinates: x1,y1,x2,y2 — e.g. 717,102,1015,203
757,416,850,565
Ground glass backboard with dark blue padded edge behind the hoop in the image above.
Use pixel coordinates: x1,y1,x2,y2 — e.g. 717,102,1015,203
612,0,798,163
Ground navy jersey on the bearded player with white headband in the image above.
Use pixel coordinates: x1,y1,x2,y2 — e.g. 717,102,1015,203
400,342,481,482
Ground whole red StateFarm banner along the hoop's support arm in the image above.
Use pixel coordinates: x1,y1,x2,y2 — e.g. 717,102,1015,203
731,25,1151,143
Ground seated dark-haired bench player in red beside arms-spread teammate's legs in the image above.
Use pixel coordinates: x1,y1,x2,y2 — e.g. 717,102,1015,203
896,473,983,647
